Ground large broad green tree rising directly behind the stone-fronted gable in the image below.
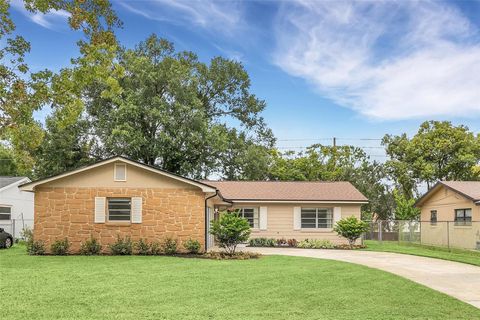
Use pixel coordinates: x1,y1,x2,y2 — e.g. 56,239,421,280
82,35,273,178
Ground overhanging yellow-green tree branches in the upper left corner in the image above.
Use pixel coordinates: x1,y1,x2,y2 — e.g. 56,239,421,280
0,0,120,174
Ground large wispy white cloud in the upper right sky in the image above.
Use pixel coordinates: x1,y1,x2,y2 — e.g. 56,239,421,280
274,1,480,120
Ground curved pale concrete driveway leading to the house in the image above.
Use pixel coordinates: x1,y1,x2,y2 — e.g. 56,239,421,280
242,247,480,308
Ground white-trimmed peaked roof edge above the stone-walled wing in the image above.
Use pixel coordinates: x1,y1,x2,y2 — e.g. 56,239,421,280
21,157,215,192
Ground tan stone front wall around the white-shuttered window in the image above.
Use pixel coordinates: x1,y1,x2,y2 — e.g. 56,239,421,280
34,187,205,252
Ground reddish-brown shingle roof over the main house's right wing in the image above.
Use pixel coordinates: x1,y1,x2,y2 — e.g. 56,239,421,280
205,181,368,203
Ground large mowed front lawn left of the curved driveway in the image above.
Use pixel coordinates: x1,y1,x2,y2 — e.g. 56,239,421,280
0,246,480,320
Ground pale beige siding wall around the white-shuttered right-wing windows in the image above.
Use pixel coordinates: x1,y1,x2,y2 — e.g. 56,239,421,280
229,203,360,243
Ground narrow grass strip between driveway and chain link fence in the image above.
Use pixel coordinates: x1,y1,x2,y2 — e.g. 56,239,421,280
363,240,480,266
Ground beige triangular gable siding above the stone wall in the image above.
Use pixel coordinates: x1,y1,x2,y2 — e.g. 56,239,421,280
42,162,198,189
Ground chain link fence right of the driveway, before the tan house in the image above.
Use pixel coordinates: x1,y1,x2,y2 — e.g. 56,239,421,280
364,220,480,250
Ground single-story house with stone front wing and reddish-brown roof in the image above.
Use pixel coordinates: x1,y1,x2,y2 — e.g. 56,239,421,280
21,157,367,250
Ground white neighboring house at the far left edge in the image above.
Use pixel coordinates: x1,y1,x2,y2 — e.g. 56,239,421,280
0,176,33,238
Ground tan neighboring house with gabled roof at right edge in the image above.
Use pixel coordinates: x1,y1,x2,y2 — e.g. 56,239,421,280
416,181,480,249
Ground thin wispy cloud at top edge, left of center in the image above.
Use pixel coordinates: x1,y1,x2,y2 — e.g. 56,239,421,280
120,0,244,34
